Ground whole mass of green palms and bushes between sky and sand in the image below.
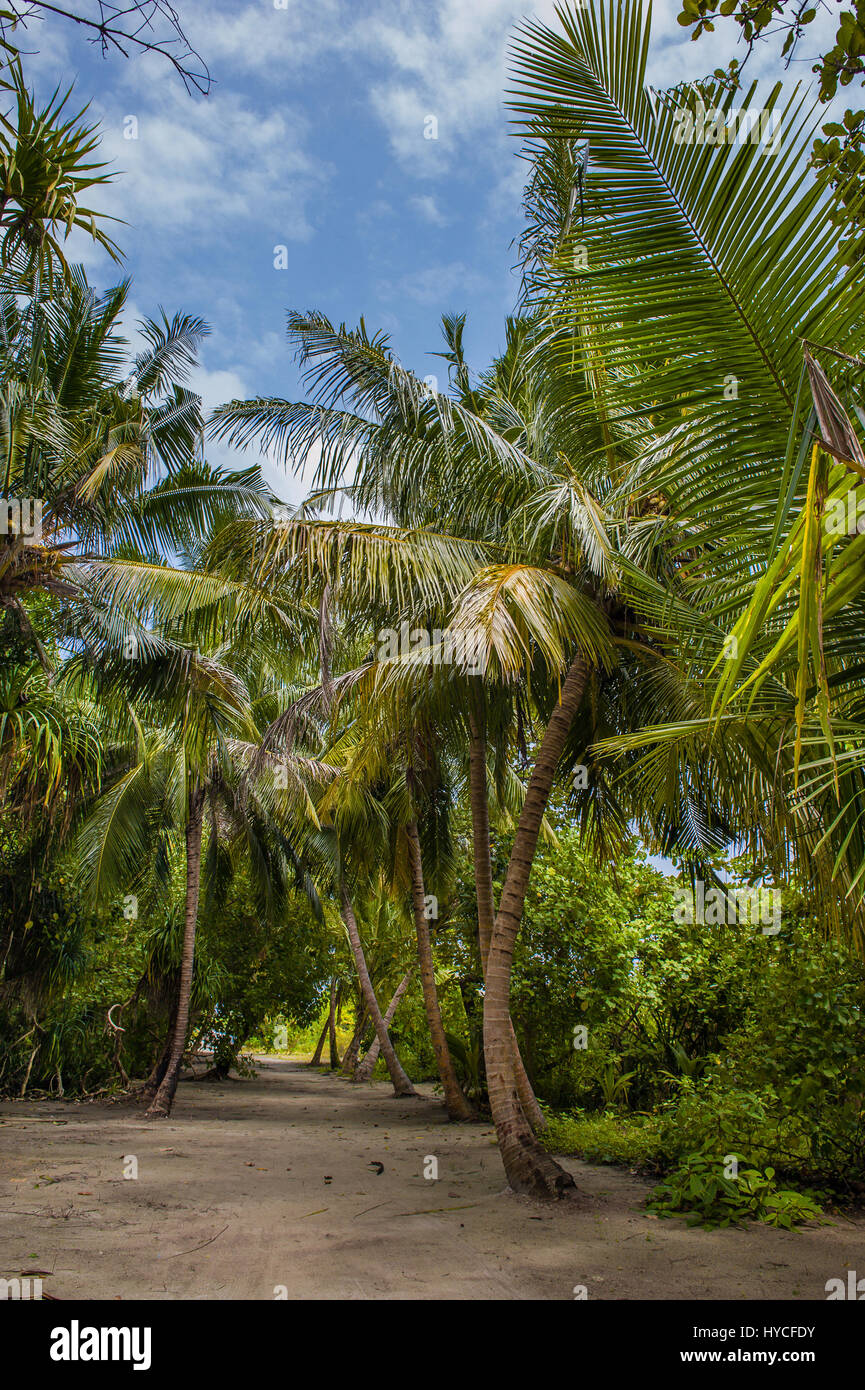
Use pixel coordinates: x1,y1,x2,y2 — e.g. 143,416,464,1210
0,0,865,1225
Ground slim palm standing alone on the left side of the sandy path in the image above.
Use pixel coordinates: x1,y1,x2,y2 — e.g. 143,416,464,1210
67,542,332,1118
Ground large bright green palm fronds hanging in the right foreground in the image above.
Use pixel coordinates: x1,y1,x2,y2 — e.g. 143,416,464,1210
515,3,865,933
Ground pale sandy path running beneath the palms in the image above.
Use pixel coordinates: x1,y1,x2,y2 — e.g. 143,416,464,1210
0,1059,865,1300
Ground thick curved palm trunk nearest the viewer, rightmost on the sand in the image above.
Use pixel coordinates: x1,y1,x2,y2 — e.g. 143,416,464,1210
484,653,588,1197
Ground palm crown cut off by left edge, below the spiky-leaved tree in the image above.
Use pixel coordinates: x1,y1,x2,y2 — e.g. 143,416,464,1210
0,268,266,613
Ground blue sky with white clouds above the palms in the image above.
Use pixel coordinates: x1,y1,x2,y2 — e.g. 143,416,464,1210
21,0,839,499
